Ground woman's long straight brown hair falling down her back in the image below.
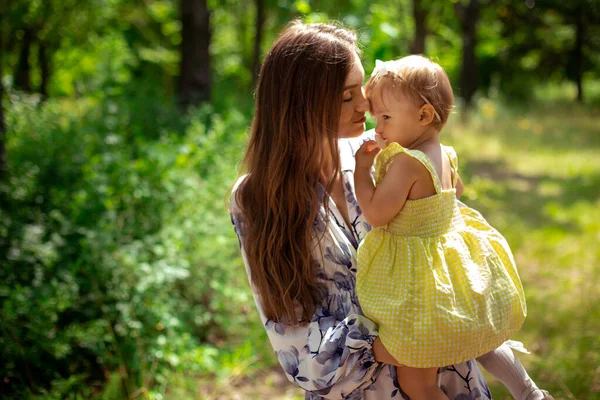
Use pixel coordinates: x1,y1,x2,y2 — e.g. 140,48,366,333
236,21,358,325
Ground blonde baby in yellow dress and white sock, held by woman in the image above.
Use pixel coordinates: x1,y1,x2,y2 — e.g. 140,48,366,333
354,56,552,400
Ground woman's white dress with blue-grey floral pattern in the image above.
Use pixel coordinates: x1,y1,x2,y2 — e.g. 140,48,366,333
230,131,492,400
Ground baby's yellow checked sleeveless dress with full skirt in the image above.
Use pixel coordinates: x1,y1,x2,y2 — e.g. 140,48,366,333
356,143,527,368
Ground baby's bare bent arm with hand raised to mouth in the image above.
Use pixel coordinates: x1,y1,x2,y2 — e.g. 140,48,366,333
354,142,419,226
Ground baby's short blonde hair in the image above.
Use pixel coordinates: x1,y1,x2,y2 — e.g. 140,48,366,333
365,55,454,129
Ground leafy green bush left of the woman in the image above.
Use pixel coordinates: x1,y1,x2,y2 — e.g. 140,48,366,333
0,93,251,398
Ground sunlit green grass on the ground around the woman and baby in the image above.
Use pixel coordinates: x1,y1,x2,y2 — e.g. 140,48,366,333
165,100,600,399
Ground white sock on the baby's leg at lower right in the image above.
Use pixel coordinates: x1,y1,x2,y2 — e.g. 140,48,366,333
477,344,544,400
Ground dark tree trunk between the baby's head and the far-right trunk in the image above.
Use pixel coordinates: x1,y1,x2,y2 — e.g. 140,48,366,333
455,0,480,113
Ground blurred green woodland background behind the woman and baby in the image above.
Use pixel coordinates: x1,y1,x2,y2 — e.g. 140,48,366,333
0,0,600,400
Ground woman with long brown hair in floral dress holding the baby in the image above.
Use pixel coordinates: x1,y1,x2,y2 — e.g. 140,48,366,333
231,22,548,400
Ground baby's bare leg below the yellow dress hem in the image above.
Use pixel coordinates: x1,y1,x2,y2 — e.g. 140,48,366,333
396,367,448,400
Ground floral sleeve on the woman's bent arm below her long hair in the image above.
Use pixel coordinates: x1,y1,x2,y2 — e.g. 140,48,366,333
230,180,382,399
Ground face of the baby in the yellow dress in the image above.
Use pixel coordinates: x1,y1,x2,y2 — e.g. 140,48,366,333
369,90,423,147
